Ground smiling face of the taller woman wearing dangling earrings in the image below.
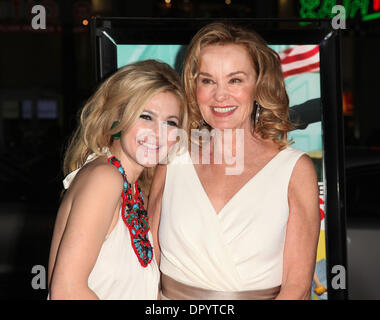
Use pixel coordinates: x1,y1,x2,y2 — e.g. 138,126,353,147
196,44,257,130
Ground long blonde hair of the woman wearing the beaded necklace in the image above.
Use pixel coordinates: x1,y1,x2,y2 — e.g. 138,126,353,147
63,60,188,195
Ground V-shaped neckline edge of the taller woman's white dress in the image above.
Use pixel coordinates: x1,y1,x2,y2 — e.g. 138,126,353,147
187,147,289,216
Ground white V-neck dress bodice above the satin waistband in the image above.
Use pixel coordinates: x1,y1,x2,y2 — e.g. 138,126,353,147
159,147,304,291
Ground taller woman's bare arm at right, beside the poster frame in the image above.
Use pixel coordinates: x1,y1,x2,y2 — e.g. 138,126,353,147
276,155,320,300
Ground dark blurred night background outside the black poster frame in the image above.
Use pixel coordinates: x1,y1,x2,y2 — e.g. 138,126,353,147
0,0,380,299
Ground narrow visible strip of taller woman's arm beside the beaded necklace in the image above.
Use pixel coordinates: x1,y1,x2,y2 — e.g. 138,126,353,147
148,165,166,265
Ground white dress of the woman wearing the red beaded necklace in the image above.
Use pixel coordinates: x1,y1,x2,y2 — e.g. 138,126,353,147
50,155,160,300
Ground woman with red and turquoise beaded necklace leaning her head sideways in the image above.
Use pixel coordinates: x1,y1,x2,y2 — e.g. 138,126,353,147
49,60,187,299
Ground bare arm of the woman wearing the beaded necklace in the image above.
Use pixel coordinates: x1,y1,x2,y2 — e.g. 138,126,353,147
50,165,122,299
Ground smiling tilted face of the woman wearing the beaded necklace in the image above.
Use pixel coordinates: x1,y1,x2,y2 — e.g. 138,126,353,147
114,91,181,169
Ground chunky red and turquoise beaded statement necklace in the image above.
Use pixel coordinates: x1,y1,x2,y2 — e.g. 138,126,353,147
108,156,153,268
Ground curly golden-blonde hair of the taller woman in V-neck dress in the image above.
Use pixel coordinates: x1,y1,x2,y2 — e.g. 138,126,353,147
182,22,294,149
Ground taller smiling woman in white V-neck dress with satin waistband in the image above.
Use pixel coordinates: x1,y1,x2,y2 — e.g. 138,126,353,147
148,22,320,299
